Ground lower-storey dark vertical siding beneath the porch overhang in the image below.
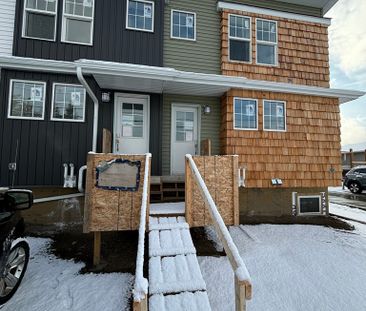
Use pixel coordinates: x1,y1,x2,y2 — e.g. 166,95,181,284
0,70,162,186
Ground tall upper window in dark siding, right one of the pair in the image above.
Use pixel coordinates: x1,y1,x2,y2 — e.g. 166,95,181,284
61,0,94,45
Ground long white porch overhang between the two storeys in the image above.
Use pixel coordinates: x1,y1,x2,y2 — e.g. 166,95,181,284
0,56,366,104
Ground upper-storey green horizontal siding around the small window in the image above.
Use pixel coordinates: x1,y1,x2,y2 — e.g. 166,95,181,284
164,0,221,74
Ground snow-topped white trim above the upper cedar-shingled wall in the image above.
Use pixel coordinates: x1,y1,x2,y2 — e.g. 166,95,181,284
217,1,331,26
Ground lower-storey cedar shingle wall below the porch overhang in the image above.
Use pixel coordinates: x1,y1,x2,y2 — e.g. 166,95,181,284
221,90,342,188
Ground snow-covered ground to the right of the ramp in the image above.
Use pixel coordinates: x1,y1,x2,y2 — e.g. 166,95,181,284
199,225,366,311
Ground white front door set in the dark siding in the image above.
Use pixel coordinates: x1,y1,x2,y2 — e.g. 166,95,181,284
113,94,150,154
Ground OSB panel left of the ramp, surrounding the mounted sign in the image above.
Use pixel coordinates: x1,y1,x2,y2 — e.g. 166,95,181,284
84,153,151,232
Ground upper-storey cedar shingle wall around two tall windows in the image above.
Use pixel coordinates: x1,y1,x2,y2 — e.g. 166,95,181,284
221,10,330,87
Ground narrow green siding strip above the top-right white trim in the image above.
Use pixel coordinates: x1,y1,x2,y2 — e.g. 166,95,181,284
225,0,323,17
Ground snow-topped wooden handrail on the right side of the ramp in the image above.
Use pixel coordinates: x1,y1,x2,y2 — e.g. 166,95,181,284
186,155,252,311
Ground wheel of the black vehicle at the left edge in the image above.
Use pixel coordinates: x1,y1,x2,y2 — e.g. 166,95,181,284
0,241,29,305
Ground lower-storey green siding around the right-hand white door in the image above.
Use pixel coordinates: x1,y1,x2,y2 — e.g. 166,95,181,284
162,95,221,175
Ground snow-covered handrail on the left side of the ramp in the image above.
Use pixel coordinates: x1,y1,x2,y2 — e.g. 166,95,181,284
133,153,151,311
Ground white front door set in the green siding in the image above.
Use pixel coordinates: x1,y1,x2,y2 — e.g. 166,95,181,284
171,105,199,175
